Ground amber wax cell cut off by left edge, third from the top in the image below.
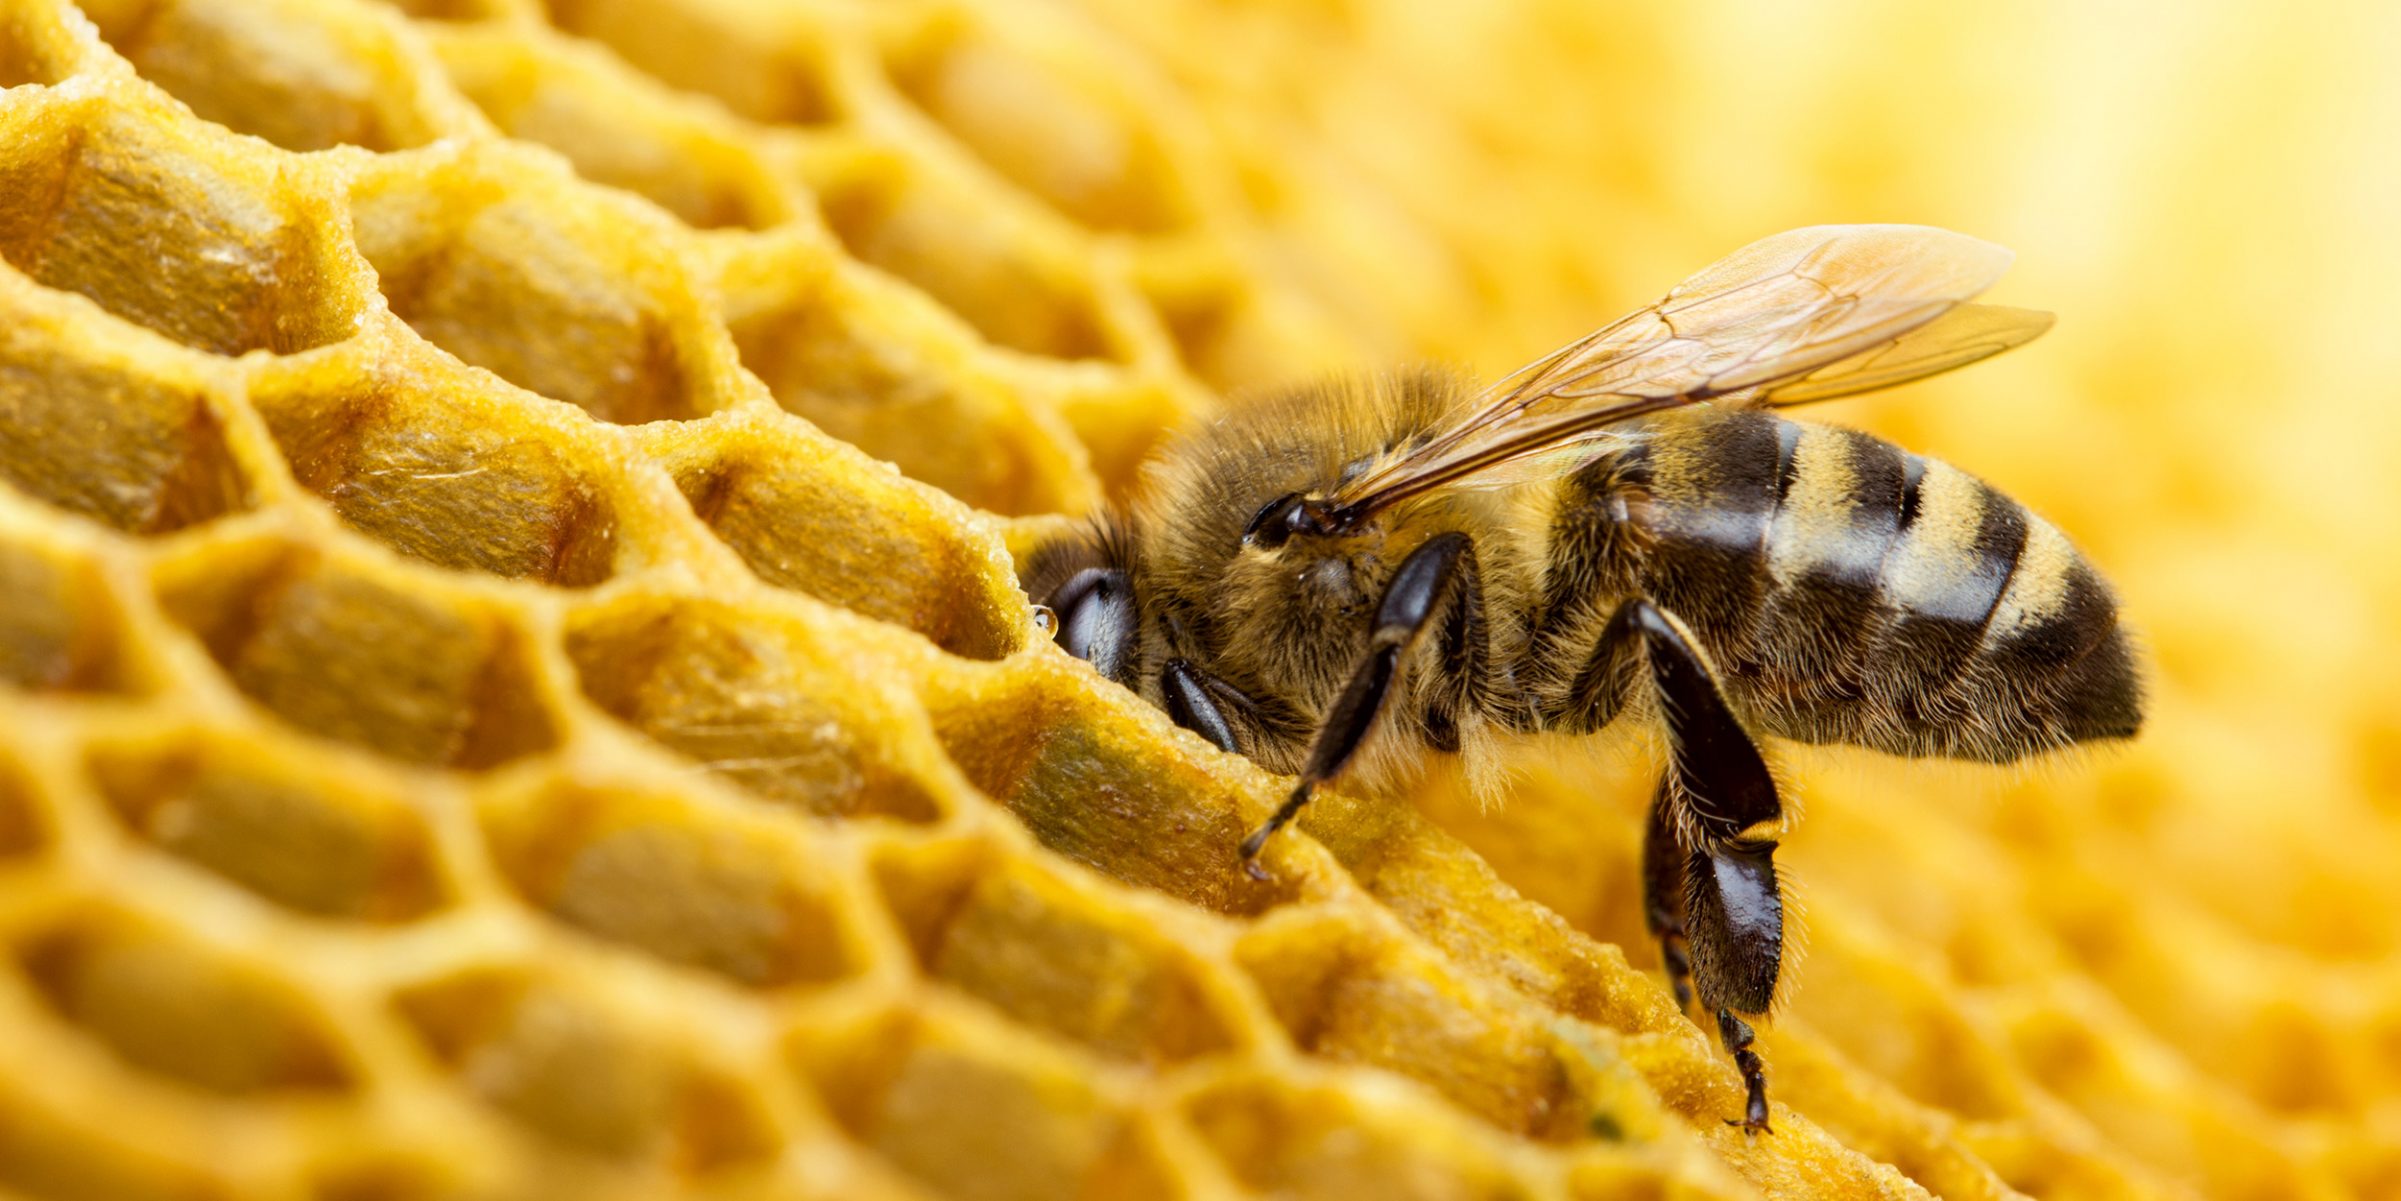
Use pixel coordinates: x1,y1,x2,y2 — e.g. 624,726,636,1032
0,279,252,533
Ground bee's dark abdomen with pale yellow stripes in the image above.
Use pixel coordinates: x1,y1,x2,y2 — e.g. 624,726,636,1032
1621,413,2139,759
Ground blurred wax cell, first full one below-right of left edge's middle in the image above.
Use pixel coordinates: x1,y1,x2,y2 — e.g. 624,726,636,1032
84,730,449,922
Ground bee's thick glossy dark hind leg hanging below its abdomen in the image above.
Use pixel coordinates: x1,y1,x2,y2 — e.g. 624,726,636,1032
1601,598,1784,1131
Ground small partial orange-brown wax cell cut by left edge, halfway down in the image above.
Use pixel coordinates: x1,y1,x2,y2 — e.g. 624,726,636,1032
0,533,134,692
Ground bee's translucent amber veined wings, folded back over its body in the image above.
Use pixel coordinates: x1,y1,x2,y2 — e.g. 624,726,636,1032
1335,226,2050,512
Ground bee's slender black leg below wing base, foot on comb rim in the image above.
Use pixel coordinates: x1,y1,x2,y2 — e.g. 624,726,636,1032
1241,533,1467,879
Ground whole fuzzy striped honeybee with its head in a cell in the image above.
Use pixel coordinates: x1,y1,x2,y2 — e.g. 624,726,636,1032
1025,226,2142,1131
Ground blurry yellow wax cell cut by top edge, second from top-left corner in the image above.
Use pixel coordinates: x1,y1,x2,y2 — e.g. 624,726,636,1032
79,0,458,151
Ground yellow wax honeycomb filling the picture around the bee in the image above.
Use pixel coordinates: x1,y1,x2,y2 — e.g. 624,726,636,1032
0,0,2401,1201
